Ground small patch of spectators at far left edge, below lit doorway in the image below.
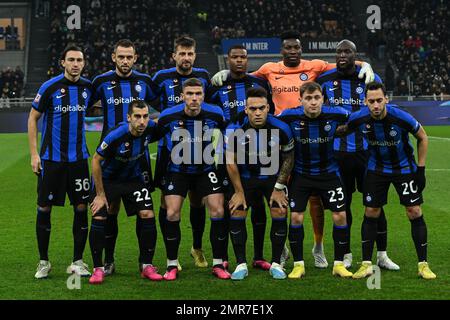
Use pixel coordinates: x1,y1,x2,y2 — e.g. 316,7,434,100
0,66,24,108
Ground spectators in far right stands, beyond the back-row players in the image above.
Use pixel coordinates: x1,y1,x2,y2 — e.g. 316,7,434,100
378,0,450,97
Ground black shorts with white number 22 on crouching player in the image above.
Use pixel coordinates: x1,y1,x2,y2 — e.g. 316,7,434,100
89,180,153,217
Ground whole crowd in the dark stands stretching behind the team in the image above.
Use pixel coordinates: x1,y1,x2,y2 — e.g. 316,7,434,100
41,0,450,96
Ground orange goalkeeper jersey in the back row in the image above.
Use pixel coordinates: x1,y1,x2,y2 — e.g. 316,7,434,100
252,59,336,115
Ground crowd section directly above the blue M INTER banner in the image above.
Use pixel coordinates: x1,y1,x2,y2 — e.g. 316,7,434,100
208,0,359,50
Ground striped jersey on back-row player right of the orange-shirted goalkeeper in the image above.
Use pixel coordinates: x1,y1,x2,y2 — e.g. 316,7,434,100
316,66,382,152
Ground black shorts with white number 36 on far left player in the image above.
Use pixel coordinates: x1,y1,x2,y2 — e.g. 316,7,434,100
37,159,90,207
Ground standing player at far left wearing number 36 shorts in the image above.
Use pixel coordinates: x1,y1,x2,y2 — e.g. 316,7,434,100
28,46,92,279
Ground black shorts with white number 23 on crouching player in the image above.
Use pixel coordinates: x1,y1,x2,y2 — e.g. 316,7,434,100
288,172,345,212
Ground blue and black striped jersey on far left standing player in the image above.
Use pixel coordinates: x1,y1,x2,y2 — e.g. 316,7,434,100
32,73,92,162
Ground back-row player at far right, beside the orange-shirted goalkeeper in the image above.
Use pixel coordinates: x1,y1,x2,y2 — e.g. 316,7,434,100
317,40,400,270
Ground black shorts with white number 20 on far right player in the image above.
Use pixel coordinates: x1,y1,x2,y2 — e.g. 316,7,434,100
363,171,423,208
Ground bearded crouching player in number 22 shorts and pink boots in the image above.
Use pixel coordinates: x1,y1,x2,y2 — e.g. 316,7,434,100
89,100,163,284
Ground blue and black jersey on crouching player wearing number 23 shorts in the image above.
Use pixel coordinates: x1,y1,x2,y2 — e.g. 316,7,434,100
279,106,349,175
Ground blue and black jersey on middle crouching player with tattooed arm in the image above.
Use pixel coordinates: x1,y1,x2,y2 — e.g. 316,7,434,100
225,114,294,179
